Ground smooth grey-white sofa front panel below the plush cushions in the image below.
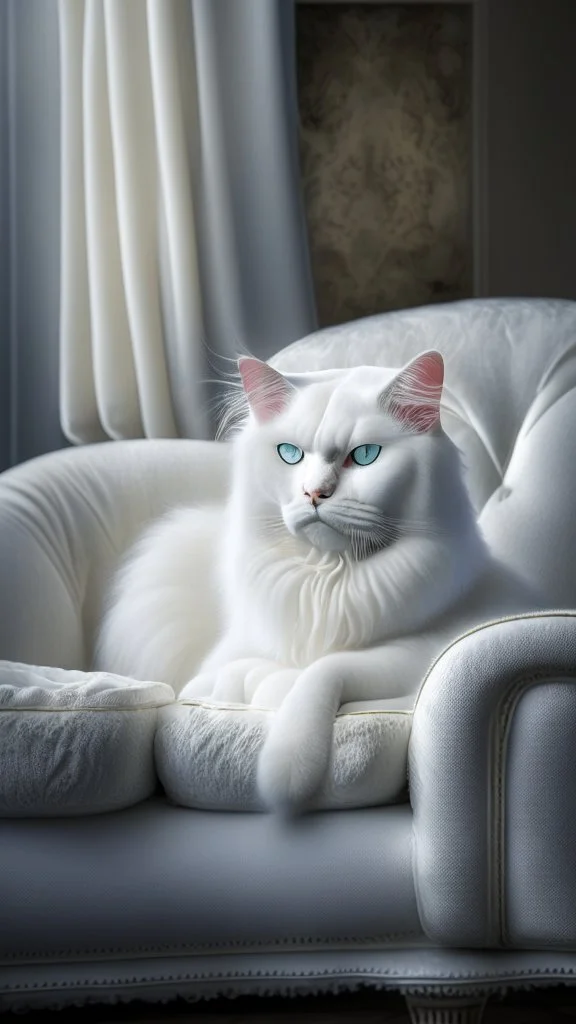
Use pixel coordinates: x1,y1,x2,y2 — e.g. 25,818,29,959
0,798,425,964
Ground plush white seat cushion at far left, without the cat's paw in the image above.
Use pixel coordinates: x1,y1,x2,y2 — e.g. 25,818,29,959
0,662,173,817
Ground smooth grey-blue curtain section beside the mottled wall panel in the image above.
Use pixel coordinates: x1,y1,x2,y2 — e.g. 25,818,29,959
191,0,316,358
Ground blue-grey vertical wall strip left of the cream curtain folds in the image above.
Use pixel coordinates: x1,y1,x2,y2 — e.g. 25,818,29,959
0,0,65,468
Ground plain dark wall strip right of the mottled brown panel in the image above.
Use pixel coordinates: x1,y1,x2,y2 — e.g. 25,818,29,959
474,0,576,299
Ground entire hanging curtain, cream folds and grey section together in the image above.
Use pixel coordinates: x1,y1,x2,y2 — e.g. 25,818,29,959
58,0,316,443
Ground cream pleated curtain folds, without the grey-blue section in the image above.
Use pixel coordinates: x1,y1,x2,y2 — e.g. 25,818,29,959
59,0,204,443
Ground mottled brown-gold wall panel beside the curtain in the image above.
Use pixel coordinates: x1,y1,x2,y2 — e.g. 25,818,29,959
296,3,471,326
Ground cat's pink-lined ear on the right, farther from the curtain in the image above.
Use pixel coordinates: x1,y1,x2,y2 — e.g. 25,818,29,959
378,351,444,433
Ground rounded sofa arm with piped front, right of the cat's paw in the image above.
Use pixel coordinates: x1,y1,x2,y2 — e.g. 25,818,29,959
409,611,576,948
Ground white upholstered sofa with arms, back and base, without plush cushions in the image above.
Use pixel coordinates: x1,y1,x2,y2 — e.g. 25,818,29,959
0,300,576,1024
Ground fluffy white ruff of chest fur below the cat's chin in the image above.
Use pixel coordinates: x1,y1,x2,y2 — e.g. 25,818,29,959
223,516,486,668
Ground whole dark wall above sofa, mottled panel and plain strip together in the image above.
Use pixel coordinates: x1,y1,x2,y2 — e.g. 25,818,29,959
297,0,576,324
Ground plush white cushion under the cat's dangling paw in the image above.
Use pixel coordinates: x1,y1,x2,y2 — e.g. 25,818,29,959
155,697,414,811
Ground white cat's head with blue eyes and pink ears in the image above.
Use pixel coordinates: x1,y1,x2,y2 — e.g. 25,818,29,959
231,351,462,558
